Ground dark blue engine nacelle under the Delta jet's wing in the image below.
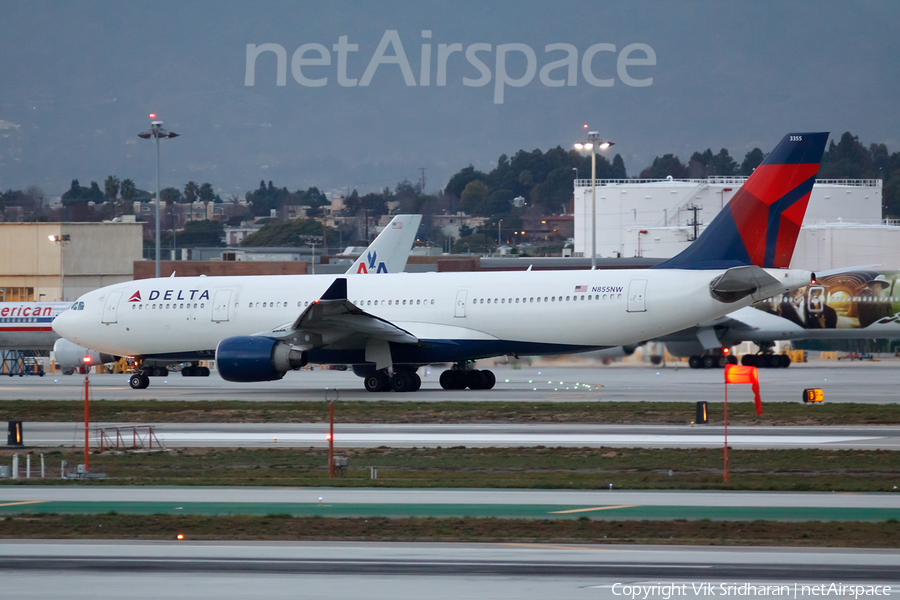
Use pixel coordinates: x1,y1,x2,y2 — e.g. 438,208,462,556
216,335,308,383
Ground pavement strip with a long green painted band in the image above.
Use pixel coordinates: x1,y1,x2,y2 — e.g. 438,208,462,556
0,485,900,521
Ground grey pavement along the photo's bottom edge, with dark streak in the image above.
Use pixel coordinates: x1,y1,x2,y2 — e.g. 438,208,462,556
0,541,900,600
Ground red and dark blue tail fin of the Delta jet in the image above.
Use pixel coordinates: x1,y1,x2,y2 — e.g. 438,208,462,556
652,132,828,269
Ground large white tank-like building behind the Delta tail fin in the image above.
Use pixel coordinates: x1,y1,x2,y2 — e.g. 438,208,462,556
574,177,888,270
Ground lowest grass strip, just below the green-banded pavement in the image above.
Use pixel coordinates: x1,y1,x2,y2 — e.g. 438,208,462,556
0,513,900,548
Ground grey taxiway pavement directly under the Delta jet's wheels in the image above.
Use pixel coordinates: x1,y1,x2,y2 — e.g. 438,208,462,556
7,359,900,404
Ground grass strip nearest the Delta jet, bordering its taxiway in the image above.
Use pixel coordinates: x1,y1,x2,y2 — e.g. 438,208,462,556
0,400,900,426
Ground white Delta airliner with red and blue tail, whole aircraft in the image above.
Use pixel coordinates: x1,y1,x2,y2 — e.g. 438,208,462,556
53,133,828,391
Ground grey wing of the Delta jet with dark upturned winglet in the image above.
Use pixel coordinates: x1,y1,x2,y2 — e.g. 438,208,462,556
264,277,419,350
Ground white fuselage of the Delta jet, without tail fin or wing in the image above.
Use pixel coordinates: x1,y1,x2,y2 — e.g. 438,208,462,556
54,270,809,364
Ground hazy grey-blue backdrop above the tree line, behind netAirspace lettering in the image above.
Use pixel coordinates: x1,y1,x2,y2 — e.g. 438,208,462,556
0,0,900,196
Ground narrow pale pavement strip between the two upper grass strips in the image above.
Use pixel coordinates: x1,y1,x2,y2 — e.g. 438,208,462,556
17,422,900,450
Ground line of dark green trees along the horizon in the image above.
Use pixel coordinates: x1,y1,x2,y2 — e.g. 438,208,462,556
0,132,900,231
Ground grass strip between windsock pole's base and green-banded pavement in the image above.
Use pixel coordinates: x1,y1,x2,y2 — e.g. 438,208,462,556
7,447,900,493
